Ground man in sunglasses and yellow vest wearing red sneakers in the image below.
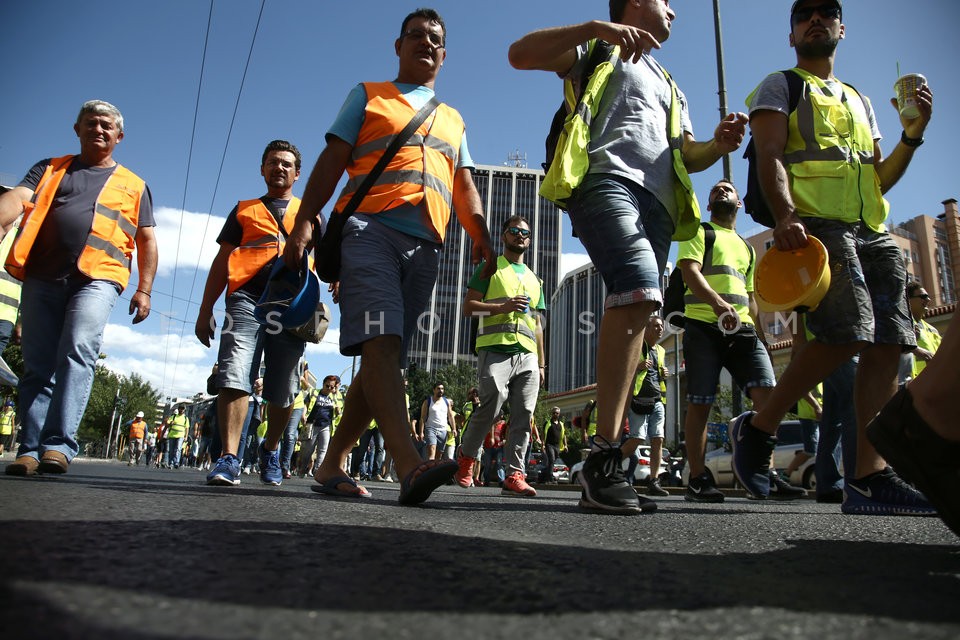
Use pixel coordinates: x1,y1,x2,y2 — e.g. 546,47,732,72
456,215,546,497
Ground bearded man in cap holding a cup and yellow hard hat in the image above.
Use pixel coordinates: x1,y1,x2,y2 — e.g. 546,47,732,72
730,0,933,515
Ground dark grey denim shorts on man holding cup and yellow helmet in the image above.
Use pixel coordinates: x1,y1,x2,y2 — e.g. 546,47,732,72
803,218,917,350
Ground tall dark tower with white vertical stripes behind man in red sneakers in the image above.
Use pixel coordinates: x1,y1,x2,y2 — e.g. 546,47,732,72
408,165,562,371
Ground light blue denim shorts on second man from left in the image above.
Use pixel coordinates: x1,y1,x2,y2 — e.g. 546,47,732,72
214,292,305,407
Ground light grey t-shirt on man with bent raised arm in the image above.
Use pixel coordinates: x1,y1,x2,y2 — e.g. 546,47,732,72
567,44,693,215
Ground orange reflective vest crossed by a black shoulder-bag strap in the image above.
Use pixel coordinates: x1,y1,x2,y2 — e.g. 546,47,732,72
336,82,464,242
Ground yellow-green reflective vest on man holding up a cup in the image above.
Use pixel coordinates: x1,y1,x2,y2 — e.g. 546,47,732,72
783,68,889,232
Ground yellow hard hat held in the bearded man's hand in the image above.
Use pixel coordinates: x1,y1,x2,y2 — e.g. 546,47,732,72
753,236,830,312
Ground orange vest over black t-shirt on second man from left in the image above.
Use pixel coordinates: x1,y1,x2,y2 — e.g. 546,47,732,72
227,197,300,295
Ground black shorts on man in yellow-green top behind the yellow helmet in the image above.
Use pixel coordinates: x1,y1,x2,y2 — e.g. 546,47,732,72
683,318,777,404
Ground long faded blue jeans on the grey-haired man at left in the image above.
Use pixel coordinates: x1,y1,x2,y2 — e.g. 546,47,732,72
17,277,120,460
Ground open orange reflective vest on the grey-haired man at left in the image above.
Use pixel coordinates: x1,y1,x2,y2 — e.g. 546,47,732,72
6,156,146,289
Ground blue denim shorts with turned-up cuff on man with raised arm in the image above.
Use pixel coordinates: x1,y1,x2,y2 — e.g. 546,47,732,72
569,174,674,308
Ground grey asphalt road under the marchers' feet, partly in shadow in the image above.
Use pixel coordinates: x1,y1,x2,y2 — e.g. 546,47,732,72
0,454,960,640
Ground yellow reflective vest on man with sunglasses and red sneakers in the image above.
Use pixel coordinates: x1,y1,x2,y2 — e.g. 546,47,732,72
477,256,543,353
